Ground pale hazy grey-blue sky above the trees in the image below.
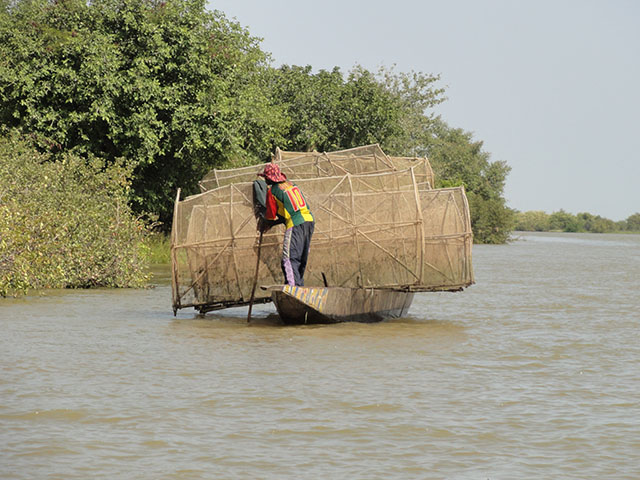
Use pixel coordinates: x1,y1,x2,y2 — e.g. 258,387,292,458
209,0,640,220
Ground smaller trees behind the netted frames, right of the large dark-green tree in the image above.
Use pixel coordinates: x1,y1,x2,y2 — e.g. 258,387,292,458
264,66,512,243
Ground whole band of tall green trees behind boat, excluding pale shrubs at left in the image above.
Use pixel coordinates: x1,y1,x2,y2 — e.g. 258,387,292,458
0,0,513,243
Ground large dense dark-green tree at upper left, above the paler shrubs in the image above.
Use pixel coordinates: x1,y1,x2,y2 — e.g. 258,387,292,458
0,0,285,225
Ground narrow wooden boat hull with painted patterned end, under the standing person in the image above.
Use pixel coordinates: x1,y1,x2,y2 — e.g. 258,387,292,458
269,285,413,325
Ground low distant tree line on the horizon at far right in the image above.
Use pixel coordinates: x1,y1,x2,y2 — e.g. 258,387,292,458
515,210,640,233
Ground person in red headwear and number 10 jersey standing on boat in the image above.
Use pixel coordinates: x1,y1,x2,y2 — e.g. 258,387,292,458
258,163,315,286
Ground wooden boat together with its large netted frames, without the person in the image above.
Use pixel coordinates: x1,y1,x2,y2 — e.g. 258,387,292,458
171,146,474,324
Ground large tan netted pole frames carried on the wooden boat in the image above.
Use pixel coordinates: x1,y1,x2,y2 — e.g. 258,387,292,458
172,163,474,311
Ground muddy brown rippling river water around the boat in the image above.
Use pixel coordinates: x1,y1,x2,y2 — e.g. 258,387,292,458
0,234,640,480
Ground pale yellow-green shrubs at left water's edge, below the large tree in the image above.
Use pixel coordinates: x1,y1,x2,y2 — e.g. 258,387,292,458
0,135,147,296
